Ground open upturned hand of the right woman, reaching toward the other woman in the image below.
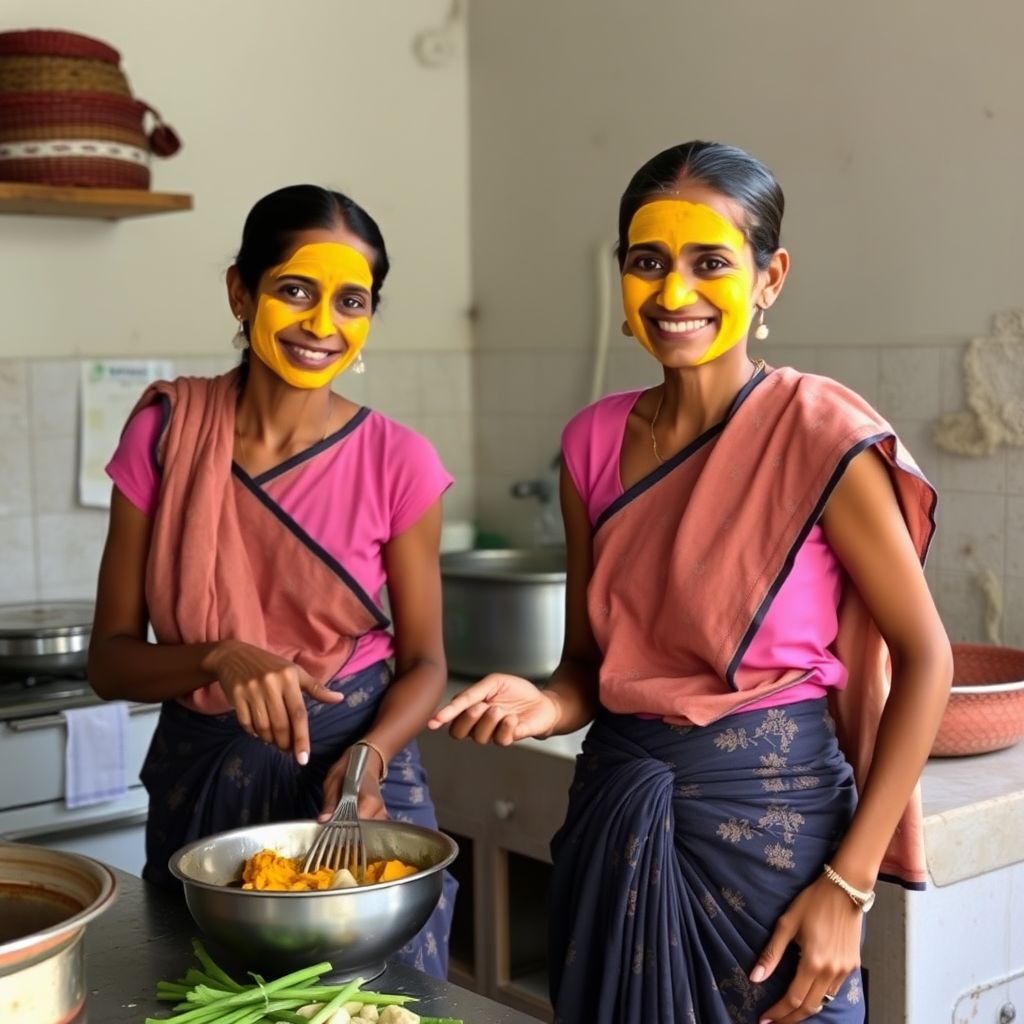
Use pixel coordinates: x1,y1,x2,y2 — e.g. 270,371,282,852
427,673,559,746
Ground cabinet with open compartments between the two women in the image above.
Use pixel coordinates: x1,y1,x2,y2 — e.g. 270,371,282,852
420,731,580,1021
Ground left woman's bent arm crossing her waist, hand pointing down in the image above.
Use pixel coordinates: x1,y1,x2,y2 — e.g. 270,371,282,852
87,487,344,764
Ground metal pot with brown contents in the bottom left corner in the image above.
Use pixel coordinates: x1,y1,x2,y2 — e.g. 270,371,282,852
0,843,117,1024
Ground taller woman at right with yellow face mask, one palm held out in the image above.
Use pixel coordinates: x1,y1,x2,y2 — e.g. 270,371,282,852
430,142,952,1024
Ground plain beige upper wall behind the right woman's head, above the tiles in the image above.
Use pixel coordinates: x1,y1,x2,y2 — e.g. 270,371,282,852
470,0,1024,360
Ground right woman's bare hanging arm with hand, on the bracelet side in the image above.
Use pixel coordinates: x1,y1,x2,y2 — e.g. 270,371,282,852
751,449,952,1024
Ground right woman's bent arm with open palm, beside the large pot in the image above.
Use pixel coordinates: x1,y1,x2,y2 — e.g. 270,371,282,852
428,463,601,746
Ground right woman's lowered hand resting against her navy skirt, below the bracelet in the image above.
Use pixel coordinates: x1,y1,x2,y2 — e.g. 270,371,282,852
751,876,864,1024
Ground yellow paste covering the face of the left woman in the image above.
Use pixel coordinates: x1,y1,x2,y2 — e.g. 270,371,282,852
249,242,374,388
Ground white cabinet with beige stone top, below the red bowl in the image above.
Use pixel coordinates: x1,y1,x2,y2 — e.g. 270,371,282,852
863,743,1024,1024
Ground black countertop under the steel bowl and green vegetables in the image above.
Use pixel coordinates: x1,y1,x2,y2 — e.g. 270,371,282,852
82,870,537,1024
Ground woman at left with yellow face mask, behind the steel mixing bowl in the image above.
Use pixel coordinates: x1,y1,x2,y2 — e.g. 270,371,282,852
89,185,456,978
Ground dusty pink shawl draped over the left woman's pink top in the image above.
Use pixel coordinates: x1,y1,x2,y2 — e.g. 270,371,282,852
136,372,379,714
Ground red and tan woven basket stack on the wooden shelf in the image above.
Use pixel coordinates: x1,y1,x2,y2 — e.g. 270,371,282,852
0,29,180,188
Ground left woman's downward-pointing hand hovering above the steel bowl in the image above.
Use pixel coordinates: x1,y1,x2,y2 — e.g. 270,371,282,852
204,640,344,765
